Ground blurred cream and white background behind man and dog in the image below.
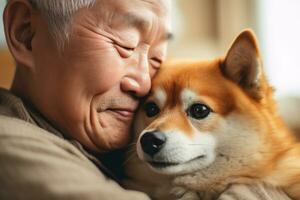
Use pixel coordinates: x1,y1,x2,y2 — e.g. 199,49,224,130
0,0,300,96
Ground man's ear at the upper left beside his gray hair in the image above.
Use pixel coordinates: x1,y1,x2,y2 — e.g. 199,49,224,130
3,0,35,68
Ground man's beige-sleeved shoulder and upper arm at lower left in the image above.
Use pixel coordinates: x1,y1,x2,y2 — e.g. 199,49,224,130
0,117,149,200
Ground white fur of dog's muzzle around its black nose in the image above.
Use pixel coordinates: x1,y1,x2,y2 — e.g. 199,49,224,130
137,129,216,174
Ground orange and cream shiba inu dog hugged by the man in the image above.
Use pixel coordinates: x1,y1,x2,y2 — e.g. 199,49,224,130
126,30,300,200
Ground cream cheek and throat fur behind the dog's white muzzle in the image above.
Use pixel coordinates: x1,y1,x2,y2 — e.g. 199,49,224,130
174,113,262,191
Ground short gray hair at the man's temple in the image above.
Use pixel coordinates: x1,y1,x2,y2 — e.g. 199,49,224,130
29,0,97,47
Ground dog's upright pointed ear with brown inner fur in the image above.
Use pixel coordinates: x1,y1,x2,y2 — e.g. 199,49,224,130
221,30,263,99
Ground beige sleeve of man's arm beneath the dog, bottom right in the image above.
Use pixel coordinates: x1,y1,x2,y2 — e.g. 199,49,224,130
218,184,291,200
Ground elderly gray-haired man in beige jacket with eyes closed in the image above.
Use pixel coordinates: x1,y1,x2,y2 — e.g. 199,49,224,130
0,0,290,200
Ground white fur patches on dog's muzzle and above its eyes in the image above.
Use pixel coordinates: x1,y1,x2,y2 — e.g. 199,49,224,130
135,88,216,174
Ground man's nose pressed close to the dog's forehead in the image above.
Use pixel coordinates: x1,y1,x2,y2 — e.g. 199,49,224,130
121,55,151,97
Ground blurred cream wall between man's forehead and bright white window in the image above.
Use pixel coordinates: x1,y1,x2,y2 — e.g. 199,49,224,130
169,0,258,59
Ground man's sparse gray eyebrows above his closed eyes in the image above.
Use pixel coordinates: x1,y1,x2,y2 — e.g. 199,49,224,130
113,12,174,41
